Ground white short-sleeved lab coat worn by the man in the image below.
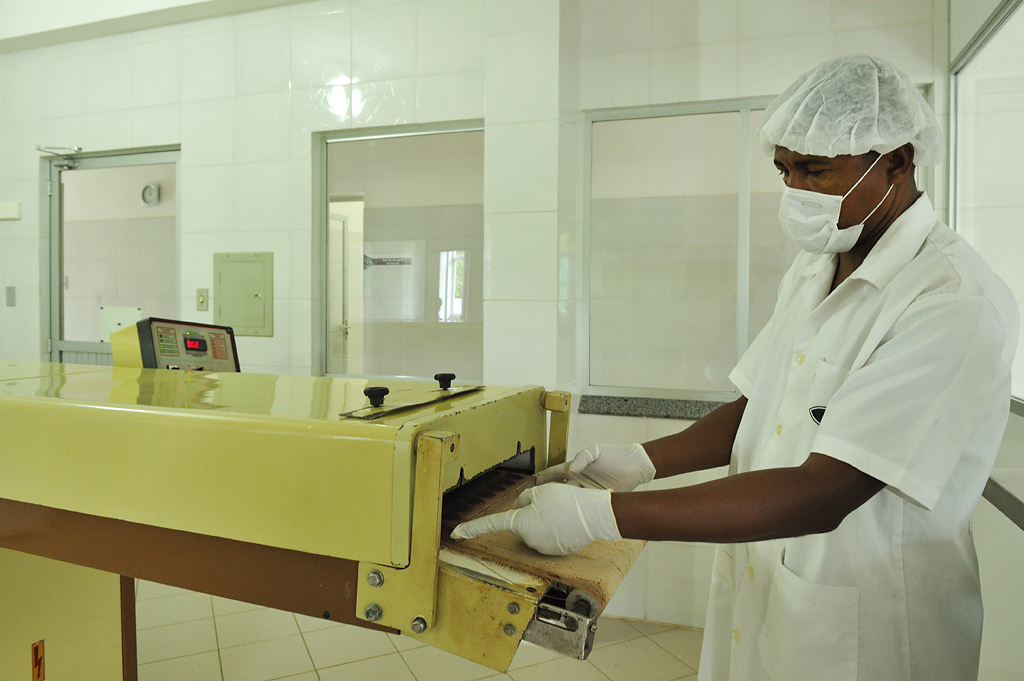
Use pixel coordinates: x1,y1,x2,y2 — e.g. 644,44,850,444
699,195,1019,681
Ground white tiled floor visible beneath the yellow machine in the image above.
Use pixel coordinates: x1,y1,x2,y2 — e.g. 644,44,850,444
136,582,702,681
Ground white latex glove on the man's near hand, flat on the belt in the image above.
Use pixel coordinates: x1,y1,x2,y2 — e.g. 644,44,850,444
452,484,623,556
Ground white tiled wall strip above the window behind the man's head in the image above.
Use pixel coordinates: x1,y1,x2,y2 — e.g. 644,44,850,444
581,0,946,109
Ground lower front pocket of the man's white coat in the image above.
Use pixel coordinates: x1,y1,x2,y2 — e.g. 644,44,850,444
758,552,860,681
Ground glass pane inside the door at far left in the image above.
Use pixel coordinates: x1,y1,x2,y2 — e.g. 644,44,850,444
60,163,178,343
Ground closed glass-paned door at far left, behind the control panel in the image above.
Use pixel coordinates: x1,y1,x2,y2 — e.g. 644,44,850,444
46,151,179,365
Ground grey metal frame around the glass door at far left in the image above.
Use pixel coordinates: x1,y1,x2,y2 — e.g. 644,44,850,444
39,144,181,363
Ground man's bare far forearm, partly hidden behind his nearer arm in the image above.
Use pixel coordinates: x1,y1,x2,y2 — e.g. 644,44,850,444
643,397,746,477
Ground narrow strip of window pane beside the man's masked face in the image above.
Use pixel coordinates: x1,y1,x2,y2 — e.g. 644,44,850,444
748,111,800,342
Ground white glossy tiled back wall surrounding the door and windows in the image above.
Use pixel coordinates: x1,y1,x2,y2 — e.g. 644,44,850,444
0,0,947,624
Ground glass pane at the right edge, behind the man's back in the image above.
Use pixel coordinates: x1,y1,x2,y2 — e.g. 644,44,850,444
955,3,1024,396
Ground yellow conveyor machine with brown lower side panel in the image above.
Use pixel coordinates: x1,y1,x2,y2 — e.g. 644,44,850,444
0,360,642,681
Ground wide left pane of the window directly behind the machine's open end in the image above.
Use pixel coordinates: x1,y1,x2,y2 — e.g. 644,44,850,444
590,113,739,391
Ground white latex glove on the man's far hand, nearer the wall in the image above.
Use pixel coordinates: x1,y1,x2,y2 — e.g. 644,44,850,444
537,443,654,492
